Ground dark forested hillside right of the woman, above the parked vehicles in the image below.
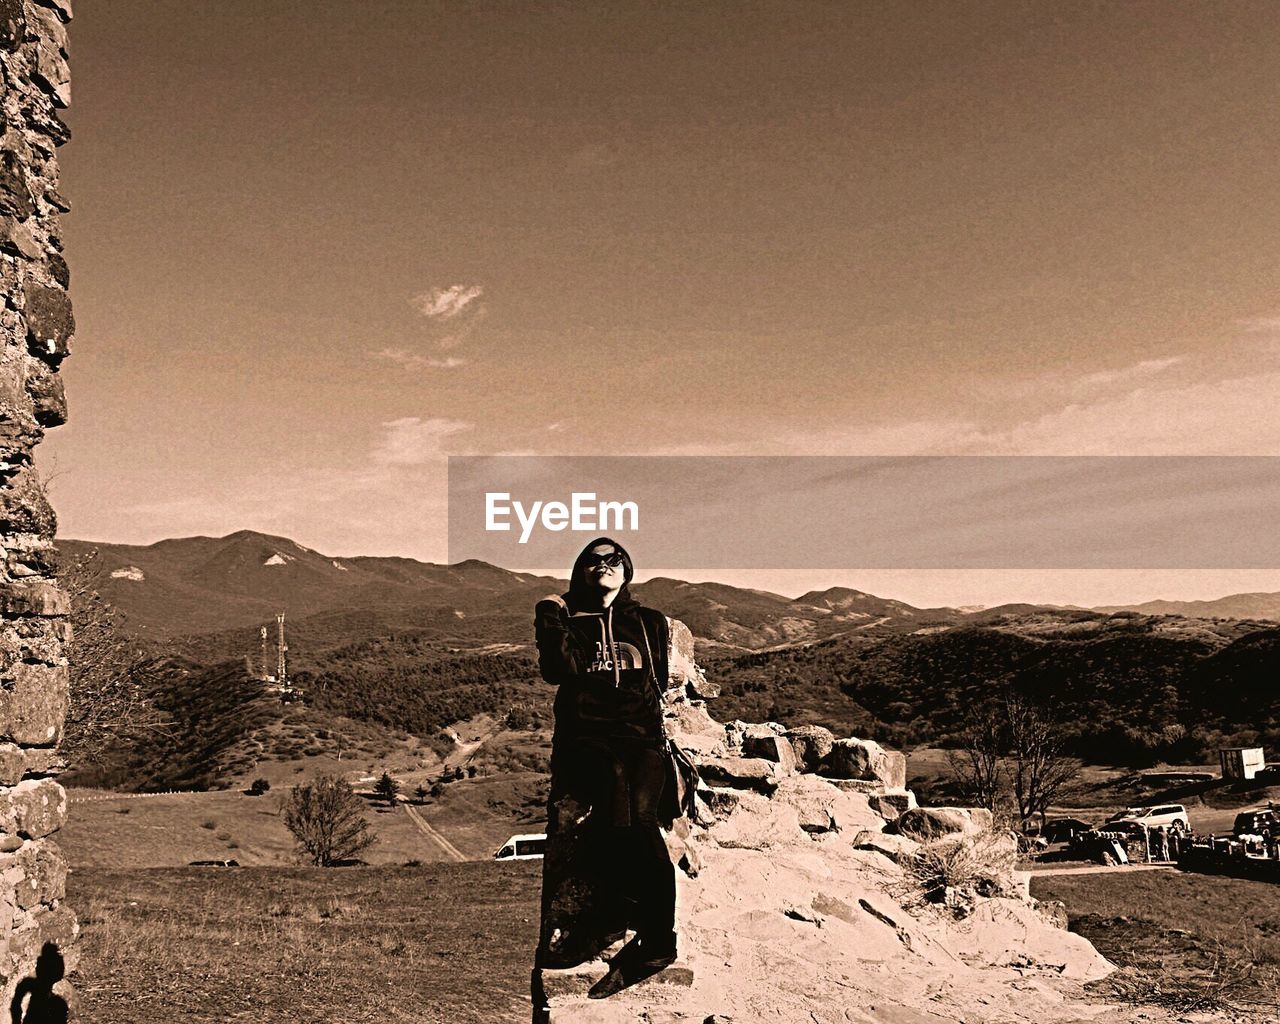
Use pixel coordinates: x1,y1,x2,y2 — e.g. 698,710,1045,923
708,614,1280,764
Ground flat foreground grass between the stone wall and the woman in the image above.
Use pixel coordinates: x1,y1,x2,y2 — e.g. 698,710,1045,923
68,861,541,1024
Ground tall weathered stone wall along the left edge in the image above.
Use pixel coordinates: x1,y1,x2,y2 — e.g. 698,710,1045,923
0,0,78,1019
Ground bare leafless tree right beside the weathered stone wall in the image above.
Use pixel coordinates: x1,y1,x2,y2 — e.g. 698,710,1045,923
58,550,166,765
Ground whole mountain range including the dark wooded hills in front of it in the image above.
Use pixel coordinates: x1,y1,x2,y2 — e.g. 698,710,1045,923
59,531,1280,787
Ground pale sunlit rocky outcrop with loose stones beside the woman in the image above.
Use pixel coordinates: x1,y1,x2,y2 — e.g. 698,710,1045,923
544,619,1208,1024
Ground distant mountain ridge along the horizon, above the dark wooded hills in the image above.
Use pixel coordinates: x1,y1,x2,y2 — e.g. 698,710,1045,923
59,530,1280,653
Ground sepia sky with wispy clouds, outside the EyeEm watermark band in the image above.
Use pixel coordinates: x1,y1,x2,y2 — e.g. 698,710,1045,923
41,0,1280,603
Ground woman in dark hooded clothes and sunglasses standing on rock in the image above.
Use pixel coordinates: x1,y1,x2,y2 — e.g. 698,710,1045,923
534,538,676,1006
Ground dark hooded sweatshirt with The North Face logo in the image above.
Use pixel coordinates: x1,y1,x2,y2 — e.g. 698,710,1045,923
535,538,669,744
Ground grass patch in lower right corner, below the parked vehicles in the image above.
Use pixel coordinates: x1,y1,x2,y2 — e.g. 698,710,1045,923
1032,872,1280,1021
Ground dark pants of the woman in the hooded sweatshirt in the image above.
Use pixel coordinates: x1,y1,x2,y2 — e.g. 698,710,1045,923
552,739,676,942
